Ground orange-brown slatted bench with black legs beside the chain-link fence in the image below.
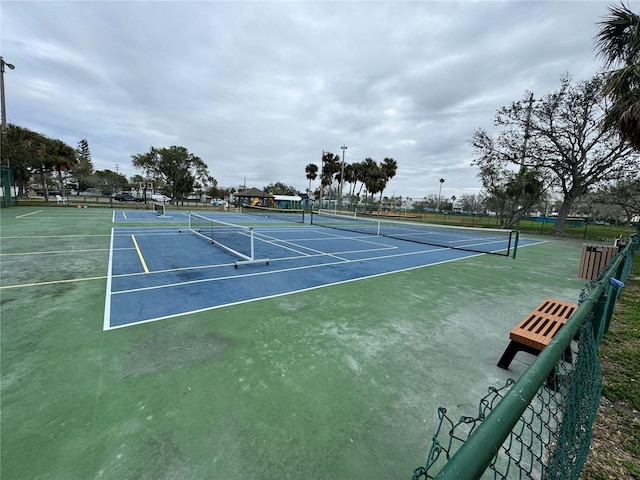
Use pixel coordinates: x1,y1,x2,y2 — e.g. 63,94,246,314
498,298,578,370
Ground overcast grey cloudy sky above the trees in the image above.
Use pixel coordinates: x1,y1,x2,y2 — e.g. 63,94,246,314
0,0,619,198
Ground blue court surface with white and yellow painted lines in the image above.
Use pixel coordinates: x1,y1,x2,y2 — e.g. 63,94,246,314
104,210,538,330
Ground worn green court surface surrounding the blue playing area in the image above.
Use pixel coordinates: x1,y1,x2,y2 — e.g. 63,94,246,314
0,207,586,480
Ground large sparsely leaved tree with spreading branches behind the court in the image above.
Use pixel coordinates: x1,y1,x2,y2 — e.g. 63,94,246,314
471,75,640,233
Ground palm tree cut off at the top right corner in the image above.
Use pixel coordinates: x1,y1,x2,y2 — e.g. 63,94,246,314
596,4,640,150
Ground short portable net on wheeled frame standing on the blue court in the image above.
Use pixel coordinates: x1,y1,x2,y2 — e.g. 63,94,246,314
189,212,269,268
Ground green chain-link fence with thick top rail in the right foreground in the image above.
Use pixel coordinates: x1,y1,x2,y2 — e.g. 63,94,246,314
412,227,640,480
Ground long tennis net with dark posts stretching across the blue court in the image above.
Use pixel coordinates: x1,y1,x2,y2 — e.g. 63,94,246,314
311,211,518,256
